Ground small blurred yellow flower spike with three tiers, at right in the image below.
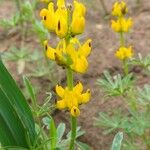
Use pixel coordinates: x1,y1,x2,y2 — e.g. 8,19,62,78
111,1,133,61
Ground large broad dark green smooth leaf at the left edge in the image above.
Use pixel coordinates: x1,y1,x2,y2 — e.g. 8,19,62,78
0,60,35,148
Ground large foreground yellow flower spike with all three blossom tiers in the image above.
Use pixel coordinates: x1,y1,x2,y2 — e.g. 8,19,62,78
40,0,91,117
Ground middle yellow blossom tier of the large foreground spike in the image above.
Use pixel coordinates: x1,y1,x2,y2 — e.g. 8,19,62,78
44,38,91,73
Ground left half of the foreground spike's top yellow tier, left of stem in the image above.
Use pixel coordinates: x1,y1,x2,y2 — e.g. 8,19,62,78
40,0,68,38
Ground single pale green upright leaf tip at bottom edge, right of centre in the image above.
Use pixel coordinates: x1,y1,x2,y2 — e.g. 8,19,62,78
111,132,123,150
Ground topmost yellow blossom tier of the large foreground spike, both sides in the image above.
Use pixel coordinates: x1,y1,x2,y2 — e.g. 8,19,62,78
40,0,86,38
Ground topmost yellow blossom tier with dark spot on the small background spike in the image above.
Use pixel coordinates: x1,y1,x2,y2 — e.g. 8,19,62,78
112,1,128,17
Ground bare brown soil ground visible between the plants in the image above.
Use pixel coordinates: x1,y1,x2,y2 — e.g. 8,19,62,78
0,0,150,150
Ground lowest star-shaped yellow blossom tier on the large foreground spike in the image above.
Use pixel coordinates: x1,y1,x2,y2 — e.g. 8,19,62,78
56,82,91,117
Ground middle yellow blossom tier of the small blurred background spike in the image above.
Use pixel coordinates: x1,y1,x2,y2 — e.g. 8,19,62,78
111,17,133,32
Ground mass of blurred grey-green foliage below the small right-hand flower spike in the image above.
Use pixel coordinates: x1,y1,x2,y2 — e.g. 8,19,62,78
95,51,150,150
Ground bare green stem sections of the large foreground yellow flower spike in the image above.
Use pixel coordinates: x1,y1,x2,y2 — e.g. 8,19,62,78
67,67,77,150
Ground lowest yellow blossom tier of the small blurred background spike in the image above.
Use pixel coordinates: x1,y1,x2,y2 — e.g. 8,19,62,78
115,46,133,60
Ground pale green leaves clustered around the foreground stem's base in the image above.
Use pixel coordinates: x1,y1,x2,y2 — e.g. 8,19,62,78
42,117,90,150
